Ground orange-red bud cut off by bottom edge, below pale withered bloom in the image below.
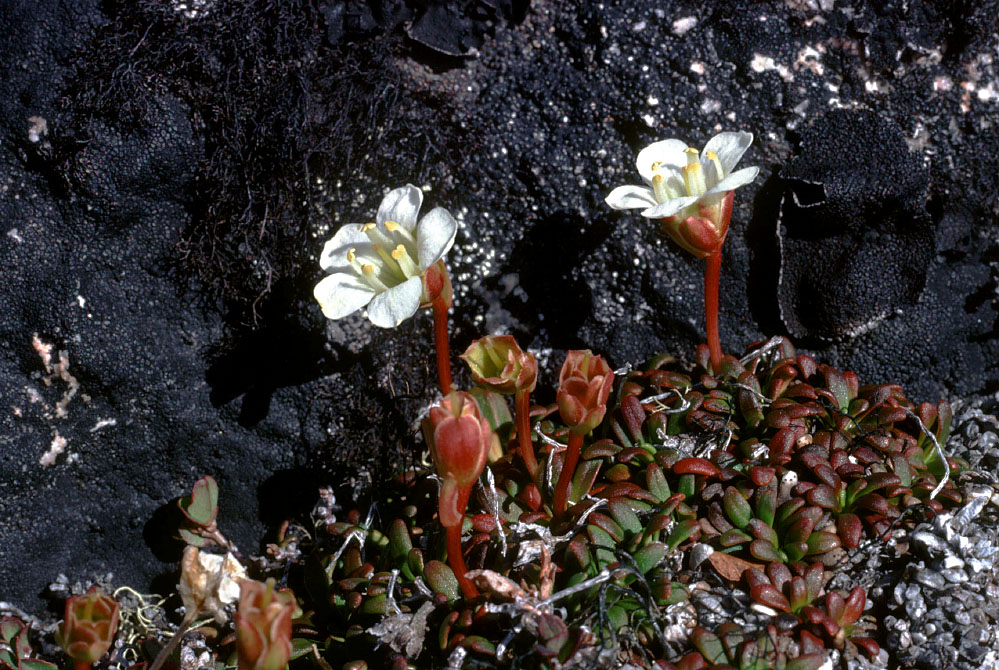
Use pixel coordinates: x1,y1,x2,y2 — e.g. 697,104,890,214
235,579,301,670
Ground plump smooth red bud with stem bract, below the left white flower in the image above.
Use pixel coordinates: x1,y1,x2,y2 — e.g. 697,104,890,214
423,391,497,527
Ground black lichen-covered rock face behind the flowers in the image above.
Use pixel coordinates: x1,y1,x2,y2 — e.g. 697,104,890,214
0,0,999,624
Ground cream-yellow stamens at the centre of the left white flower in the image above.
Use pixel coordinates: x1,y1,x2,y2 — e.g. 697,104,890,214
347,221,423,292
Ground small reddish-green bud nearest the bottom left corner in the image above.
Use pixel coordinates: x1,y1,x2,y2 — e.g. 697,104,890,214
56,586,120,663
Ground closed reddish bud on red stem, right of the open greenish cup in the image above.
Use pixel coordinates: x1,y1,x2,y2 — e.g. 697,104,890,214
556,349,614,435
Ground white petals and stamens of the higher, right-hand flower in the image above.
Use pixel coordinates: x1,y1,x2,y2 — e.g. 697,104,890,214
606,132,760,219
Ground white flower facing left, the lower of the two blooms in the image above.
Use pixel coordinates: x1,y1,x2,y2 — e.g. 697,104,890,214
313,184,458,328
